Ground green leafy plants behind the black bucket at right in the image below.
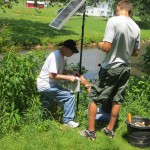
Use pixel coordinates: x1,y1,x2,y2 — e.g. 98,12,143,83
122,76,150,118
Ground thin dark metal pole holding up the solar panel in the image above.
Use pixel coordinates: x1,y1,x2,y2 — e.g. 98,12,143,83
77,2,86,112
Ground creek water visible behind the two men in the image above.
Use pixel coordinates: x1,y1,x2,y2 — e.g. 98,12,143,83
67,44,147,80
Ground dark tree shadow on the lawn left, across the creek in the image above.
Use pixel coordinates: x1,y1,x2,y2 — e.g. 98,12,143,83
0,19,77,46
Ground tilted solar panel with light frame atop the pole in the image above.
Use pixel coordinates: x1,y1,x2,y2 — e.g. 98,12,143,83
49,0,86,30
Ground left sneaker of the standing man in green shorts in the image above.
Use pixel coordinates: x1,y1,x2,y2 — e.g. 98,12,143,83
80,129,96,141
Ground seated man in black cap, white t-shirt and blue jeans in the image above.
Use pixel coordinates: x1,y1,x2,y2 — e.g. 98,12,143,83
37,40,79,128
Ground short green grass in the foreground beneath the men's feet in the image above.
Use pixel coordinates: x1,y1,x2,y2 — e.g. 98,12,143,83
0,121,149,150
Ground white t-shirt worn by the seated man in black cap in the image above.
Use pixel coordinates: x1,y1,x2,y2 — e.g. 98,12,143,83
37,50,65,92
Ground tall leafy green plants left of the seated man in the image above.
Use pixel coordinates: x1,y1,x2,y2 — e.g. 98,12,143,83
0,51,47,132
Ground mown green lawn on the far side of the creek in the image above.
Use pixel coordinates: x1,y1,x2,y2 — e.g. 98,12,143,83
0,2,150,46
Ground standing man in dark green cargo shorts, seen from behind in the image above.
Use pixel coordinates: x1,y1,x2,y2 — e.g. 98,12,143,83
82,0,140,140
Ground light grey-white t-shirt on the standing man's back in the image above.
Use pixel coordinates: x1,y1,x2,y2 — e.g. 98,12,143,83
101,16,140,69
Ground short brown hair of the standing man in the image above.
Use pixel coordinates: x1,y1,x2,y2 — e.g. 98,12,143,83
117,0,132,16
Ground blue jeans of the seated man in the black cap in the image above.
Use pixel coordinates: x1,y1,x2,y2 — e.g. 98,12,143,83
40,85,75,123
